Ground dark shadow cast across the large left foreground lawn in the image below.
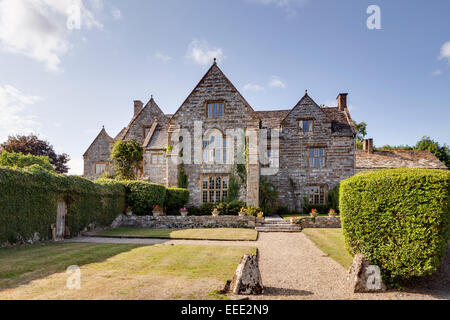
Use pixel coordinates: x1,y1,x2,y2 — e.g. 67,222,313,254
0,242,161,292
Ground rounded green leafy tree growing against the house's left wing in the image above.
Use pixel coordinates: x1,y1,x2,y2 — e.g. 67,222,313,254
111,140,144,180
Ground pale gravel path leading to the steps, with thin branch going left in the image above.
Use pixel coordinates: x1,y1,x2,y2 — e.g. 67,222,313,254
67,232,450,300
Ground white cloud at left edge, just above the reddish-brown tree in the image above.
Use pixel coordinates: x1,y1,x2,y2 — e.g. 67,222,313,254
0,85,42,141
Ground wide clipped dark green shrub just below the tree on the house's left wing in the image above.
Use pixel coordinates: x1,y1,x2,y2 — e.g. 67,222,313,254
120,180,166,215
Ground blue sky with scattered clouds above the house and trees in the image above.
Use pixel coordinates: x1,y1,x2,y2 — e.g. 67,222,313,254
0,0,450,174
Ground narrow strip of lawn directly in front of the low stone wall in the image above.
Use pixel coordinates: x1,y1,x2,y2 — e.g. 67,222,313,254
95,227,258,241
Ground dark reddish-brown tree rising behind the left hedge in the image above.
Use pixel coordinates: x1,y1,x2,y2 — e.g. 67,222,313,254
1,134,70,173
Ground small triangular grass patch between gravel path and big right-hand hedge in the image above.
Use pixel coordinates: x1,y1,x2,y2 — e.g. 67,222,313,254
302,228,353,269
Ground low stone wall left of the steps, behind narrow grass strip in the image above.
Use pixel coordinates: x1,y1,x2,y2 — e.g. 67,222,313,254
111,215,256,229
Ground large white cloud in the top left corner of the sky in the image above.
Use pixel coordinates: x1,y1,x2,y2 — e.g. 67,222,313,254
0,0,103,71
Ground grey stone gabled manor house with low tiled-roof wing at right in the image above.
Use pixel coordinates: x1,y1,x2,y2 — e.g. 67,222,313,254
83,61,445,209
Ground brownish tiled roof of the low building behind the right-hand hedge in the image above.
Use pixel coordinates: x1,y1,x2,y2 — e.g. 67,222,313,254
356,150,447,170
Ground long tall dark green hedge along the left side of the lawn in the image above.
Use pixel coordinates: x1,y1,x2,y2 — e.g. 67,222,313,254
0,165,125,243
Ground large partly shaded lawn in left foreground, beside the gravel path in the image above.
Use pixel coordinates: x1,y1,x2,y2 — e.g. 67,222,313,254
0,243,256,300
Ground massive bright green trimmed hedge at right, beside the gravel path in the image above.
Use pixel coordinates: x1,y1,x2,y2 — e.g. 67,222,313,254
340,169,450,284
